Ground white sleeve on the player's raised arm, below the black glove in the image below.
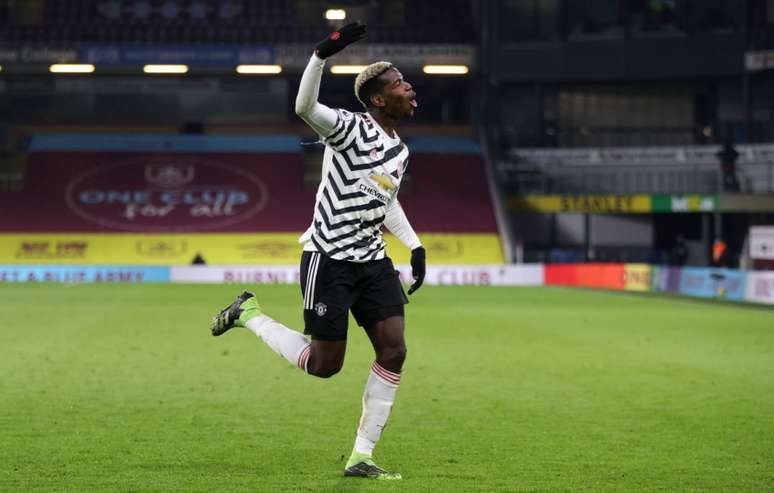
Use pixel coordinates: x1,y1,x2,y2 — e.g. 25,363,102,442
296,55,342,138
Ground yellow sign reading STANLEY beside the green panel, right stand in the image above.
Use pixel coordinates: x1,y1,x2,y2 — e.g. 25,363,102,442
508,195,652,214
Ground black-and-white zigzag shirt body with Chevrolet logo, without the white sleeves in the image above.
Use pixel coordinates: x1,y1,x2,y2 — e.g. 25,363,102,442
301,109,409,262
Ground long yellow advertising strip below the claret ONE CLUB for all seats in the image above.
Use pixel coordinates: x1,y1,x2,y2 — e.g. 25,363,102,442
0,233,503,265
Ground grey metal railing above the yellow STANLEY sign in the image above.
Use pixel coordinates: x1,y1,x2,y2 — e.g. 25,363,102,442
497,145,774,194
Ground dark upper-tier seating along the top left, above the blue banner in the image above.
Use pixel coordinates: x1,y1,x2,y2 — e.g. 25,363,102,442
0,0,474,44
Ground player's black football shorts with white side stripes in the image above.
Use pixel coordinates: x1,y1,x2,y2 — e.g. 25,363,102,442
301,252,408,341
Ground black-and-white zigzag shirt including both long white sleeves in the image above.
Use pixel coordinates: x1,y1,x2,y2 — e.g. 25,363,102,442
296,54,422,262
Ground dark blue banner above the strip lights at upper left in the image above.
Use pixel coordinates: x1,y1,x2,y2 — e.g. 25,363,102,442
79,43,275,66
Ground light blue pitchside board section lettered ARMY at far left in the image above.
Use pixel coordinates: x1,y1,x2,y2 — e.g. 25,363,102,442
0,265,170,283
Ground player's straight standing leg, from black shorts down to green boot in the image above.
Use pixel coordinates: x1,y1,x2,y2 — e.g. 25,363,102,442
344,259,407,479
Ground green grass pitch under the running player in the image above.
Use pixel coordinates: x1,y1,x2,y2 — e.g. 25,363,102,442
0,284,774,493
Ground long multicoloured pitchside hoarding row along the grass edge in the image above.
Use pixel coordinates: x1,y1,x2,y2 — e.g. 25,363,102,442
0,264,774,304
